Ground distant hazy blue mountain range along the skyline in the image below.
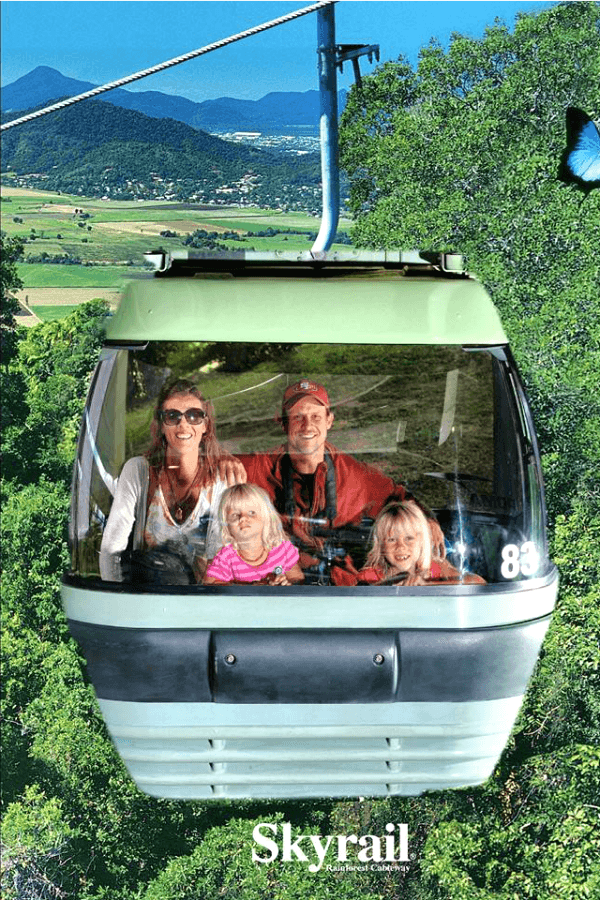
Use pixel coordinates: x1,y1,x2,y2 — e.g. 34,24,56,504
0,66,346,134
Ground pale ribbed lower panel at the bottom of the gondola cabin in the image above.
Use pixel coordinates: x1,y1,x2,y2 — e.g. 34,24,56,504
99,696,522,800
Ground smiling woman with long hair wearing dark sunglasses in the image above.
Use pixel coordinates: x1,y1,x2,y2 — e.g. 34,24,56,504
100,379,246,583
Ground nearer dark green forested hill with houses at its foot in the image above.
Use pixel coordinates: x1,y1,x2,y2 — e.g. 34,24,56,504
2,98,320,209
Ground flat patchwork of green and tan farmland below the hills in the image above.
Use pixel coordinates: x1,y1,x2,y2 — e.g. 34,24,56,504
1,185,350,324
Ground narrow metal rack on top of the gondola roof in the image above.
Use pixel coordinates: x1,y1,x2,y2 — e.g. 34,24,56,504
144,250,468,278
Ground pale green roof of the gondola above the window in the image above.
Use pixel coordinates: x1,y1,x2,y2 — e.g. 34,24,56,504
107,253,507,345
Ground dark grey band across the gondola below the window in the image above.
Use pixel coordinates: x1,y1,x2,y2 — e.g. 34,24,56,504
69,617,549,703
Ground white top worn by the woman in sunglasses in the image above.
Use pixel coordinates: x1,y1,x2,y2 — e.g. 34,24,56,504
100,456,227,581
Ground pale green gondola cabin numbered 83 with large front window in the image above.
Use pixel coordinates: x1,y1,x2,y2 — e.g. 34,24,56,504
63,252,558,799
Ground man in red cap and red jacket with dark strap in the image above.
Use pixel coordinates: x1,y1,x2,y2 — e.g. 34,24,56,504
240,379,443,584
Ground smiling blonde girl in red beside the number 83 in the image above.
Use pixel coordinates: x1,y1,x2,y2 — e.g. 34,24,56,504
358,503,485,586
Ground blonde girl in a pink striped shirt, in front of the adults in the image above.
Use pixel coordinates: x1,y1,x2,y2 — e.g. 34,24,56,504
204,484,304,584
